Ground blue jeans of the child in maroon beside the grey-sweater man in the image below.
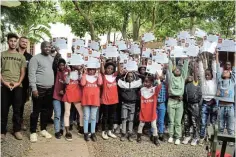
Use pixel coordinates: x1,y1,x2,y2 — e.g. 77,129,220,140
53,100,64,133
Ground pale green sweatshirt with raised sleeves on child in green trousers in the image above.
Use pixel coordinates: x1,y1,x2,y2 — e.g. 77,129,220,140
168,60,189,96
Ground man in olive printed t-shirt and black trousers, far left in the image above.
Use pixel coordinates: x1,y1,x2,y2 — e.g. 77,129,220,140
0,33,26,140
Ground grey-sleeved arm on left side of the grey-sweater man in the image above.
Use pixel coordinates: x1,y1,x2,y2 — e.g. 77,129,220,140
29,57,38,91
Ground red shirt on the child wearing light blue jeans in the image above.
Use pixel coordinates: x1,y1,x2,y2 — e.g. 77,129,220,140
81,74,102,106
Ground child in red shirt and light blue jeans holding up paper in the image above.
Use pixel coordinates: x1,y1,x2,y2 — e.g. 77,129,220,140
81,63,102,142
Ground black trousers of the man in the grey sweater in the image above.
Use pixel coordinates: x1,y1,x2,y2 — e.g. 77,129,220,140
30,87,52,133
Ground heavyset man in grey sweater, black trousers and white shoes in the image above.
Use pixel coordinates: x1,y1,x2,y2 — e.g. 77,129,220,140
29,41,54,142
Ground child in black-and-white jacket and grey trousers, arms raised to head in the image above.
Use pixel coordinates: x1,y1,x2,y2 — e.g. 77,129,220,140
118,72,142,142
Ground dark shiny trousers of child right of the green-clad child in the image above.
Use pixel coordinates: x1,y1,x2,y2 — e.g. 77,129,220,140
184,103,200,138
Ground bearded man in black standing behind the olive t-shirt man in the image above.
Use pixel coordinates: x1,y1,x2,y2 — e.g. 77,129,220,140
18,37,32,131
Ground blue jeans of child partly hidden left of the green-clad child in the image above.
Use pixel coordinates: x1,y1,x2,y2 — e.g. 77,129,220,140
156,103,166,134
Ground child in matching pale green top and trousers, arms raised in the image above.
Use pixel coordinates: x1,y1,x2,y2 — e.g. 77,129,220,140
167,57,189,145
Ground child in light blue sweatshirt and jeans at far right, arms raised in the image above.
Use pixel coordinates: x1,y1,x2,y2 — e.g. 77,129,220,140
216,52,236,146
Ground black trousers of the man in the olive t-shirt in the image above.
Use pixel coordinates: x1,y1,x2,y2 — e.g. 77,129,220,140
1,85,22,134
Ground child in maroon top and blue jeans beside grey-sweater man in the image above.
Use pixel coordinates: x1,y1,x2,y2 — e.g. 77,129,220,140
53,59,68,139
